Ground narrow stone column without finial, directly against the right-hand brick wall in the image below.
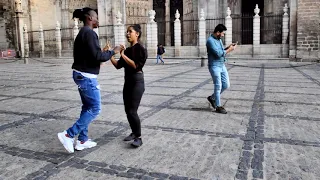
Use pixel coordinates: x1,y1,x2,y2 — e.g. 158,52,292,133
289,0,298,59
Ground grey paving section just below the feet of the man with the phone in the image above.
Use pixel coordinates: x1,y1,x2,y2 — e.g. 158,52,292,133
143,109,249,136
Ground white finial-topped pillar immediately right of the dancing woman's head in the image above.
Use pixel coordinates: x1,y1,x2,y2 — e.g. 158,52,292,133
147,10,158,57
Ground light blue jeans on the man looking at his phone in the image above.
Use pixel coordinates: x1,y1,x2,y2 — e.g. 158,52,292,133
209,63,230,106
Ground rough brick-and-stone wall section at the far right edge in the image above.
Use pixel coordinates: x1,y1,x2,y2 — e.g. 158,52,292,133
297,0,320,59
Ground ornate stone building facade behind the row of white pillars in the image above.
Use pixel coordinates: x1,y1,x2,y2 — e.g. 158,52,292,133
0,0,320,59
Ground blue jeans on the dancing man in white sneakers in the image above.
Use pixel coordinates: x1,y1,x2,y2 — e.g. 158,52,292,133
67,71,101,142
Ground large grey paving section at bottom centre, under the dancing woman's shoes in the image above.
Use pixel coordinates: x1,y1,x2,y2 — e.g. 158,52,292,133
84,129,241,179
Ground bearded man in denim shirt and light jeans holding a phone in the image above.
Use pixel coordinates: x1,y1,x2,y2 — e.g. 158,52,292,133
206,24,237,114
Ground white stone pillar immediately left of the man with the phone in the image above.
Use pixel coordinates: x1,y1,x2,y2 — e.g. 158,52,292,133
198,9,206,57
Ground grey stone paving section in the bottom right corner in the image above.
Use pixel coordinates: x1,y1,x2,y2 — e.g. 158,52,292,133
265,143,320,180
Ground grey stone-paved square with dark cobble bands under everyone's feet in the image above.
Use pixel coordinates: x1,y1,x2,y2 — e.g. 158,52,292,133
0,60,320,180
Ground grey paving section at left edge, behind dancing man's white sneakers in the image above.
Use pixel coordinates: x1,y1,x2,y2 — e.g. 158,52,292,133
0,118,114,153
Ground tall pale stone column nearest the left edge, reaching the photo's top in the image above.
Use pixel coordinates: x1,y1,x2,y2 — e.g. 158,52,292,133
15,0,24,57
